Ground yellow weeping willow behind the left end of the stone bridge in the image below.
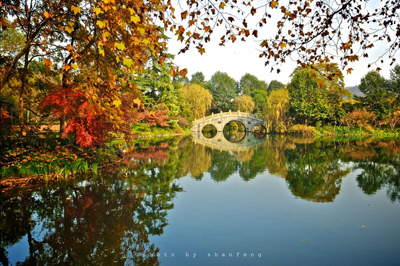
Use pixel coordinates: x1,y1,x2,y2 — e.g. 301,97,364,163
181,84,213,118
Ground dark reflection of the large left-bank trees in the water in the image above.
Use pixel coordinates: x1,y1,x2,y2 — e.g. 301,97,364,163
1,156,181,265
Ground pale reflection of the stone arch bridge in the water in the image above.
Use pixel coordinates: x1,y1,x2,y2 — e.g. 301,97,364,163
192,132,265,152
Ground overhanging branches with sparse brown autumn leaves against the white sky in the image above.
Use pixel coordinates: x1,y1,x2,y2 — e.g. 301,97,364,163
171,0,400,73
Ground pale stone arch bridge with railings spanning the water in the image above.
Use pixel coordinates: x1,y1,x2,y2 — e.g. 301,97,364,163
192,111,264,132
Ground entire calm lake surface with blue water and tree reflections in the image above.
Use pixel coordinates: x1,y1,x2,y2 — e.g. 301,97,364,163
0,135,400,265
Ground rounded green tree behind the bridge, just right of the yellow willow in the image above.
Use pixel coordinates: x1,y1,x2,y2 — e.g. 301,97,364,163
206,71,238,112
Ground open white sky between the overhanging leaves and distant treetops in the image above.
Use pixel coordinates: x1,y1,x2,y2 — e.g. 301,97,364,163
164,1,400,86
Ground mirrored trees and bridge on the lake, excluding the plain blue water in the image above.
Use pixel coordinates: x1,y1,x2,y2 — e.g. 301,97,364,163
0,137,400,265
